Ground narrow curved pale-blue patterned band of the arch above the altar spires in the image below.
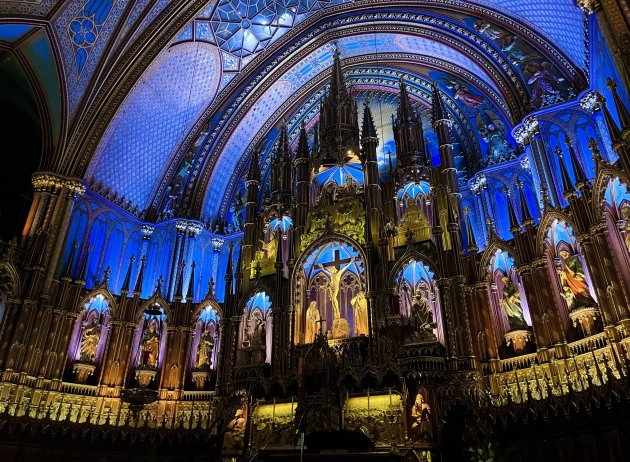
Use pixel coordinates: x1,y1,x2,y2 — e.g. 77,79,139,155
204,34,496,219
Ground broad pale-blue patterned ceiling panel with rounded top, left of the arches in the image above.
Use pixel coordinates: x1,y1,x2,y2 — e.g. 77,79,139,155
87,42,221,210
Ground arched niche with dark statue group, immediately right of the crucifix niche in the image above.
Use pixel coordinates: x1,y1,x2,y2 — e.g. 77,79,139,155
395,259,444,344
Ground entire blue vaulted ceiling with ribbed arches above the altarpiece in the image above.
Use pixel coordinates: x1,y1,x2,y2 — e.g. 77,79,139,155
0,0,587,221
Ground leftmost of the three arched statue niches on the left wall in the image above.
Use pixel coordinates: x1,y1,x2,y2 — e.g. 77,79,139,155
70,294,109,383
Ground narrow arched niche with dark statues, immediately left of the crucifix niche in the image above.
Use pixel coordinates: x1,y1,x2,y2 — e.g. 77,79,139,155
240,292,273,364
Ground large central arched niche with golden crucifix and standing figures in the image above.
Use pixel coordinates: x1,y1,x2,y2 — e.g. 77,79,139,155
295,242,369,343
